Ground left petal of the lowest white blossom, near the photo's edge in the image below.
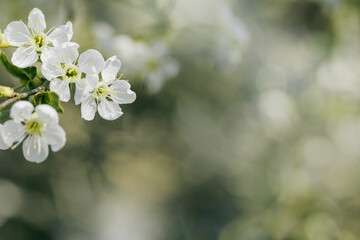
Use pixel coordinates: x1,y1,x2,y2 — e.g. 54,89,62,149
2,120,25,146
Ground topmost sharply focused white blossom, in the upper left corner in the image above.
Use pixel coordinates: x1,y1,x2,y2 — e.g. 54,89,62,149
4,8,73,68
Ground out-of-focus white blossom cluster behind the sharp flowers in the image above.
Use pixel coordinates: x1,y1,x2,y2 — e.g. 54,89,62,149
94,22,180,94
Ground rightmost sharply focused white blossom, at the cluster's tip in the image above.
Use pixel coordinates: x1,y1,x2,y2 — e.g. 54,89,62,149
81,56,136,121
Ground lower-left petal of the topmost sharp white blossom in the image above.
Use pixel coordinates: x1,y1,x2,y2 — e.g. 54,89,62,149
11,47,39,68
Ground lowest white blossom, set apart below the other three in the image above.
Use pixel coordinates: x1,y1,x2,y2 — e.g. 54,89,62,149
2,101,66,163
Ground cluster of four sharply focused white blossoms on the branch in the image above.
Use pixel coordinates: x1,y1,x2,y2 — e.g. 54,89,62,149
0,8,136,163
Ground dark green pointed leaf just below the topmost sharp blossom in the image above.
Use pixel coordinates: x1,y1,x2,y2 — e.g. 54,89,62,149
0,50,37,84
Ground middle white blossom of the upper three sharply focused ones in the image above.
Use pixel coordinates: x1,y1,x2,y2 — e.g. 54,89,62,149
41,42,105,102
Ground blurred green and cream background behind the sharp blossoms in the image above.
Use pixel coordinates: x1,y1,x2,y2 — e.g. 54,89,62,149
0,0,360,240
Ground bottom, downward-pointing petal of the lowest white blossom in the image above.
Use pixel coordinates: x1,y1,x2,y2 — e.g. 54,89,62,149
23,136,49,163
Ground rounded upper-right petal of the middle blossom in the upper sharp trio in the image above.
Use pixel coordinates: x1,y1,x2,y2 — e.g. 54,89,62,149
79,49,105,74
